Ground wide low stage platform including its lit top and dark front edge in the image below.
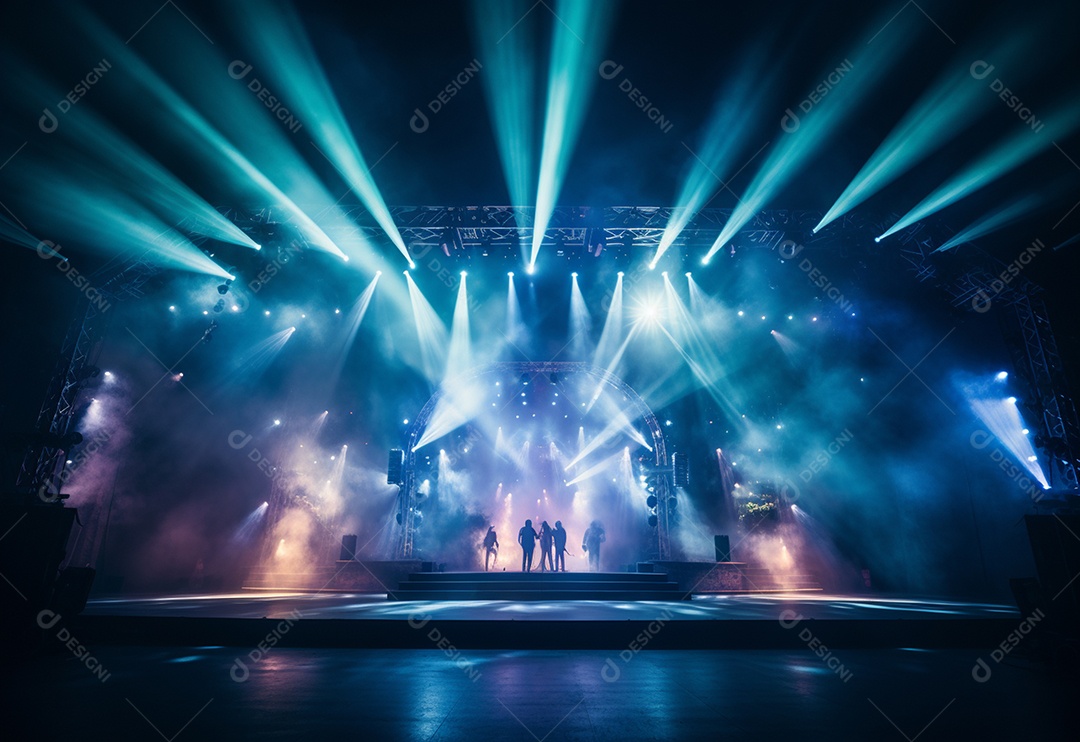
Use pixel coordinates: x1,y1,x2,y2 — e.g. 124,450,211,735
71,592,1021,649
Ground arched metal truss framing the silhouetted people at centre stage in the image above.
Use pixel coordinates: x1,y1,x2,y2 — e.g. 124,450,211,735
397,361,673,559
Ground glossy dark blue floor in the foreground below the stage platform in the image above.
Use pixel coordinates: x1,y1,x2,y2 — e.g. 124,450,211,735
10,646,1077,742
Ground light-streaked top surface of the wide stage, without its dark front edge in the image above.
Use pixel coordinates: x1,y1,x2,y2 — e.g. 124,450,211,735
83,591,1020,621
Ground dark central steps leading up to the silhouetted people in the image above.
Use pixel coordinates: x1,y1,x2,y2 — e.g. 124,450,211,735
387,572,689,601
